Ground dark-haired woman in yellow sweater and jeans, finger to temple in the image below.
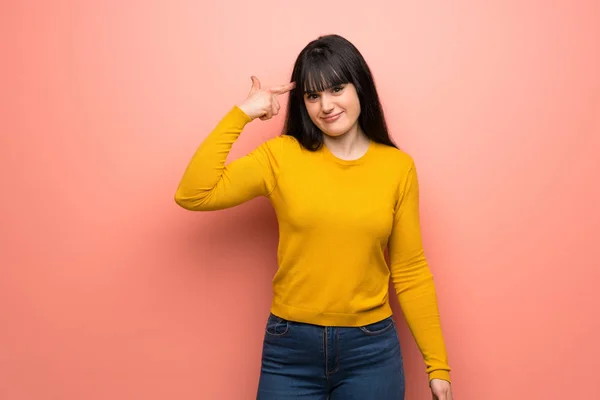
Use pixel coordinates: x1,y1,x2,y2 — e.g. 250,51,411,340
175,35,451,400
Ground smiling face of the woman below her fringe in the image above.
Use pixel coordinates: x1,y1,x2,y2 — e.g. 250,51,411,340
304,83,360,136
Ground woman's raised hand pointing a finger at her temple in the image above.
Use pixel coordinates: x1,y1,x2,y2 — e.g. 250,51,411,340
238,76,296,121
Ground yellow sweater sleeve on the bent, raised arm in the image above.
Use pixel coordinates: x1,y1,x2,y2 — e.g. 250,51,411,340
175,106,277,211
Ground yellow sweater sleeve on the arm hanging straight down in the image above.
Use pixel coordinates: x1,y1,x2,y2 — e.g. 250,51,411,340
388,160,450,381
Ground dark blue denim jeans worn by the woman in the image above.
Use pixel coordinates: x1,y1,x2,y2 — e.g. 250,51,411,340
256,314,404,400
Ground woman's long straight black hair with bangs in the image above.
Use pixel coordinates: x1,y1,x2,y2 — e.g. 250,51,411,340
283,35,397,150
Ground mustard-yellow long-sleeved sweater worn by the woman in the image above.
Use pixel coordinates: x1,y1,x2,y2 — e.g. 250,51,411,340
175,106,450,380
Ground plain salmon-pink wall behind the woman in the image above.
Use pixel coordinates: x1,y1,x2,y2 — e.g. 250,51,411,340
0,0,600,400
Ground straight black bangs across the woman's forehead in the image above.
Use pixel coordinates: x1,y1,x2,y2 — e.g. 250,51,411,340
299,52,352,93
